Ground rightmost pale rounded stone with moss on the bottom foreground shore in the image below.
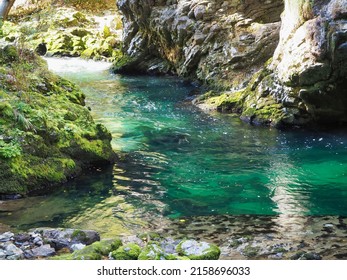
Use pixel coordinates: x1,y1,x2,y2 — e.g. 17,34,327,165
176,240,221,260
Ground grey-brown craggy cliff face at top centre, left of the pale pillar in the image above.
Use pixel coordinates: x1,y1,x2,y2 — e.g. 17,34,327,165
117,0,283,88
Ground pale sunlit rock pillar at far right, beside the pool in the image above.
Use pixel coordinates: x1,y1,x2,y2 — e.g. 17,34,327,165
271,0,347,123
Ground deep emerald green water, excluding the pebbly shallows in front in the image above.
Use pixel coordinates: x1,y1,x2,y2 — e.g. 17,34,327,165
0,57,347,238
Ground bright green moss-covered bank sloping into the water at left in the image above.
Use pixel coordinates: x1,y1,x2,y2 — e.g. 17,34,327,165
0,45,114,194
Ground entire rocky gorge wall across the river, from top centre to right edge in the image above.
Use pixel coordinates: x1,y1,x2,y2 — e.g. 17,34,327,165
115,0,347,126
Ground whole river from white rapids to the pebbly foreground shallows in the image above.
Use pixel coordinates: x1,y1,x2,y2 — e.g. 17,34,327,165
0,58,347,259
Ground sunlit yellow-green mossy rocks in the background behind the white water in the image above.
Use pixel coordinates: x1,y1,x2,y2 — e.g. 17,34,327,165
3,6,121,61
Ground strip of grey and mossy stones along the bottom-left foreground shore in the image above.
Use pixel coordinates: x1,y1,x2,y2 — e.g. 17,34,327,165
0,228,220,260
